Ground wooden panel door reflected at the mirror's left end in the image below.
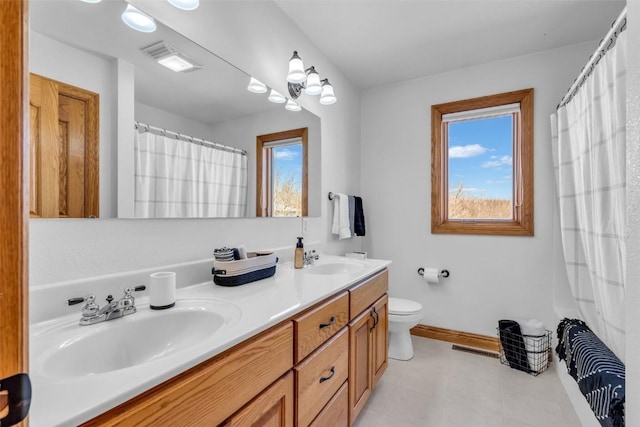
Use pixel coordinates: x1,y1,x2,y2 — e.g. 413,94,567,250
29,74,99,218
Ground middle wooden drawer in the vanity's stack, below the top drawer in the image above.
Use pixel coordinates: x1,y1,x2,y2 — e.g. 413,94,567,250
294,328,349,426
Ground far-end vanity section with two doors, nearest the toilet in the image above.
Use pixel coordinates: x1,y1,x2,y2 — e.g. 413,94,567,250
349,270,389,423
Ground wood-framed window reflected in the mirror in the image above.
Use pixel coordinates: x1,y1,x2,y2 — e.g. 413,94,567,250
256,128,308,217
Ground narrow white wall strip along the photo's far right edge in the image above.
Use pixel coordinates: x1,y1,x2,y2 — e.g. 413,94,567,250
625,0,640,426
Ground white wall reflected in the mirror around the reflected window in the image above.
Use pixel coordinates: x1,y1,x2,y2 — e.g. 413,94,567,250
211,108,325,216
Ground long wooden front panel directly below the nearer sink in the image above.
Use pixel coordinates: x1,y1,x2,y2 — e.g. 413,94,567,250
85,322,293,427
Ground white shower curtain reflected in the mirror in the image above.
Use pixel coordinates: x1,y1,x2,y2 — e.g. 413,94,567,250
134,131,248,218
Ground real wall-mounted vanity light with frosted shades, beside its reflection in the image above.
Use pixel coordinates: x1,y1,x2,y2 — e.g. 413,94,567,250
287,50,337,105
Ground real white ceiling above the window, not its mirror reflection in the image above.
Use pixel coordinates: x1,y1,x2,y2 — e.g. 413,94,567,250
274,0,625,88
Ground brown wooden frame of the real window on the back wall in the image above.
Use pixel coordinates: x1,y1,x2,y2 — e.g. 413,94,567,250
431,88,534,236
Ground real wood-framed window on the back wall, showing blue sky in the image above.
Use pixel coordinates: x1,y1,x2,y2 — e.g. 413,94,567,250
431,89,533,236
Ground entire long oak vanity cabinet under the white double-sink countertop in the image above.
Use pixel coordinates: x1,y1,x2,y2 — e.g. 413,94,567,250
83,270,388,427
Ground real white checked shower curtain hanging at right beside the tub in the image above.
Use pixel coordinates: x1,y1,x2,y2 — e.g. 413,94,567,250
551,32,626,360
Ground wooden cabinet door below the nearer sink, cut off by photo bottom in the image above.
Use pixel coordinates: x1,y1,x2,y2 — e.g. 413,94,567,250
224,372,293,427
